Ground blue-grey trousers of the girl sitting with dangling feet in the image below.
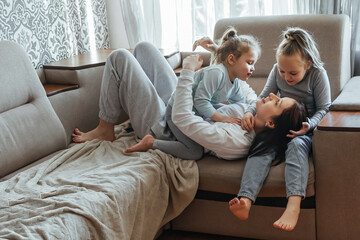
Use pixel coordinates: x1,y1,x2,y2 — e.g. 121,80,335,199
238,134,312,202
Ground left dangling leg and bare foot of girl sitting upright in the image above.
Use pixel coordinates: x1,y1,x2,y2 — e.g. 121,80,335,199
229,153,275,220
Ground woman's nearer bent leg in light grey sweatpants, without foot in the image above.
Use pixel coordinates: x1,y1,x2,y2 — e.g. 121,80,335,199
99,49,165,138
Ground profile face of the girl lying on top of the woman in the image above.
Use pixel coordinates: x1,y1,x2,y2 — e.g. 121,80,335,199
228,49,258,82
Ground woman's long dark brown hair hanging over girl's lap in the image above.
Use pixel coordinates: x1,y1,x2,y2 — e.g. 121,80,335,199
249,100,308,161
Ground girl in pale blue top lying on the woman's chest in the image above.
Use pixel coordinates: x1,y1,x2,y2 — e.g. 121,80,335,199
125,28,261,160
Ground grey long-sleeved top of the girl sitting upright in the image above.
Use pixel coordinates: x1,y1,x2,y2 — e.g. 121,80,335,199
246,64,331,129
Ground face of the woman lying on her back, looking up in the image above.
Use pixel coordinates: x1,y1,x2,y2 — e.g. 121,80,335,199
256,93,296,123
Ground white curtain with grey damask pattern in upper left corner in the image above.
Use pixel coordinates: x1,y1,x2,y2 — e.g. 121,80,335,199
0,0,110,69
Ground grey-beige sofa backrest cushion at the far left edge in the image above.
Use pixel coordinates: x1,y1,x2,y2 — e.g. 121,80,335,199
0,41,66,177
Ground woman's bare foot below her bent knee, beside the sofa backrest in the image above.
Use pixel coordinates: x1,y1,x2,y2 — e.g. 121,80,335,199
71,120,116,143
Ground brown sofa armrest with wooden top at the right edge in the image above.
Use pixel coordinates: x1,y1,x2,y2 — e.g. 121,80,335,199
313,111,360,239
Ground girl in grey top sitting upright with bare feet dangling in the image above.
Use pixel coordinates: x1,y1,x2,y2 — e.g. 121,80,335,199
229,28,331,231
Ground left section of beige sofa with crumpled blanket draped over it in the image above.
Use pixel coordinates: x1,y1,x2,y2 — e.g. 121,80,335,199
0,41,199,240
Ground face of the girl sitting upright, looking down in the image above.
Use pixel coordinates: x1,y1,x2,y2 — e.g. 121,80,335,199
278,53,311,86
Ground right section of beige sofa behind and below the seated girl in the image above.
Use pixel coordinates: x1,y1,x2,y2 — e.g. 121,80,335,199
171,15,360,240
